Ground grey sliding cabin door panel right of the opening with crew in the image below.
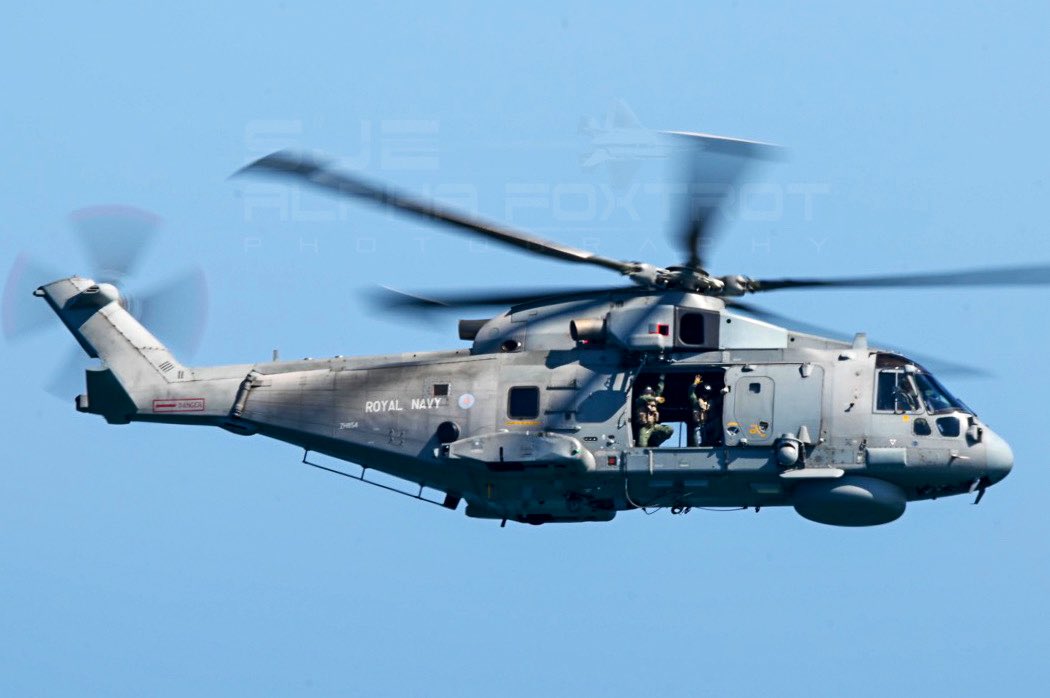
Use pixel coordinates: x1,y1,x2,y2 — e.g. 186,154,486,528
722,363,824,446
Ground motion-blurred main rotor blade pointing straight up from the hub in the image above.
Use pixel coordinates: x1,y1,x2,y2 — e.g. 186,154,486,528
666,131,782,269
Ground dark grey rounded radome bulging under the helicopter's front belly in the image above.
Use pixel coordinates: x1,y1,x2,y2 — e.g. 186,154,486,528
793,475,907,526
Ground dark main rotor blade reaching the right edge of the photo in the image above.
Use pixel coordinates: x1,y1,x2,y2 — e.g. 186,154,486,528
750,265,1050,292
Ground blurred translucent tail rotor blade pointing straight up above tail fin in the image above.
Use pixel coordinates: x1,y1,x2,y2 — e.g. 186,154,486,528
69,206,161,282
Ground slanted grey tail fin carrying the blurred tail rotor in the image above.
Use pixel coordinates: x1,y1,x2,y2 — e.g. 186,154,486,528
35,276,185,423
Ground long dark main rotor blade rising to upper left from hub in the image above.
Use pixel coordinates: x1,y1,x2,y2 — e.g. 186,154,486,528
235,150,637,274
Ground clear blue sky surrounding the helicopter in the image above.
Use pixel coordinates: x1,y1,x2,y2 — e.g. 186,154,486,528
0,2,1050,696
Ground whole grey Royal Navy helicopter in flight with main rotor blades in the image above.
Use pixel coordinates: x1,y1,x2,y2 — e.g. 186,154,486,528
35,132,1050,526
